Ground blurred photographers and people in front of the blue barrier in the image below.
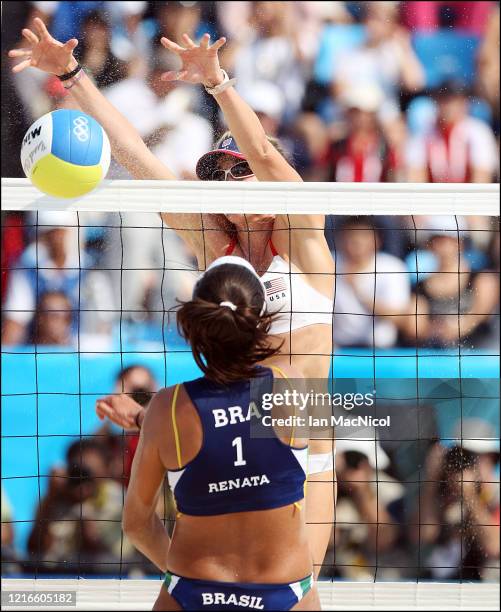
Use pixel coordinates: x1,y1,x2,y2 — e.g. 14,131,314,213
2,363,500,582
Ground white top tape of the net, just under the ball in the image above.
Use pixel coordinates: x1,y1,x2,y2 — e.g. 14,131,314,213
2,179,499,215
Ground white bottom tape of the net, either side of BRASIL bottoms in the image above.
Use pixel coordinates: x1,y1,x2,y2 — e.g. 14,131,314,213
2,579,499,610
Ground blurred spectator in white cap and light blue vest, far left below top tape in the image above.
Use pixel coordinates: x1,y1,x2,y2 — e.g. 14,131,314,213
2,211,114,345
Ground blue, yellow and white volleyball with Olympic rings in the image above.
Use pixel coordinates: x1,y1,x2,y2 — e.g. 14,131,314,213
21,109,110,198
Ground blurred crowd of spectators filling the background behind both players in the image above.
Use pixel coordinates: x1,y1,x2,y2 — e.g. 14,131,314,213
1,1,500,580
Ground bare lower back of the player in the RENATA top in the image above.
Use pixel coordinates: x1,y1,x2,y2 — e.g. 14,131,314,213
167,501,312,584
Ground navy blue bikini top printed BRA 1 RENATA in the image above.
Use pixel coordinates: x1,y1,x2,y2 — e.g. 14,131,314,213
168,367,308,516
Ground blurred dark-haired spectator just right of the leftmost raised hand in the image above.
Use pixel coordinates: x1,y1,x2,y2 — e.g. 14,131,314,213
75,10,128,88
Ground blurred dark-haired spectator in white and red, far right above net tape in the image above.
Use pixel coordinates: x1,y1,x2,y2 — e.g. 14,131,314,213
407,82,498,183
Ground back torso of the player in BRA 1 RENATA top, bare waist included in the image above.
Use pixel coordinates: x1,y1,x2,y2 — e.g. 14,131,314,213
164,368,311,583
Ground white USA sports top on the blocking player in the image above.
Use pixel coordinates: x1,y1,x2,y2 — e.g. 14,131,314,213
226,241,334,334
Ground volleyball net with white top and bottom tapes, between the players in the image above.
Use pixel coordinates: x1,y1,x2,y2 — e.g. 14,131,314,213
1,179,499,609
